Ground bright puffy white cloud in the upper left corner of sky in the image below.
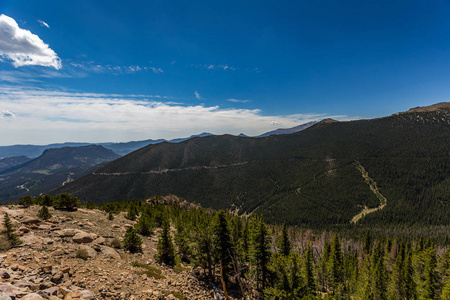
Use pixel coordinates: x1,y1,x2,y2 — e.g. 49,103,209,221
0,14,61,70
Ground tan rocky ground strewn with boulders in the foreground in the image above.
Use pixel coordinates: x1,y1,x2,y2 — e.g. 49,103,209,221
0,206,232,300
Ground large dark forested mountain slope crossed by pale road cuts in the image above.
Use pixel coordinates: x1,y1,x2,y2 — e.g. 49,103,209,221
55,103,450,226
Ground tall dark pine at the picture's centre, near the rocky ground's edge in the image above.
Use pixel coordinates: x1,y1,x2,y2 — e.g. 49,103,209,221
213,210,233,283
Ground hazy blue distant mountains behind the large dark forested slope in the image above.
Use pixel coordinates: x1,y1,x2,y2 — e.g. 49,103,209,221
0,125,316,203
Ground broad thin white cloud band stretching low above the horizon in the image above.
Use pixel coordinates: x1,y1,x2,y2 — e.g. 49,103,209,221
0,86,352,145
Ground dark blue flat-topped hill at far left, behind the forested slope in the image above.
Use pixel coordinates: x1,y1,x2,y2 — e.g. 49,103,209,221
0,145,119,202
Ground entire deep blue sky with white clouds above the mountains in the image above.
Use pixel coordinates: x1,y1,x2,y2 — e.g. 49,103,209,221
0,0,450,145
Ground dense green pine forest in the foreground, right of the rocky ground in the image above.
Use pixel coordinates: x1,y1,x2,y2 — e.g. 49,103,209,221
97,197,450,300
